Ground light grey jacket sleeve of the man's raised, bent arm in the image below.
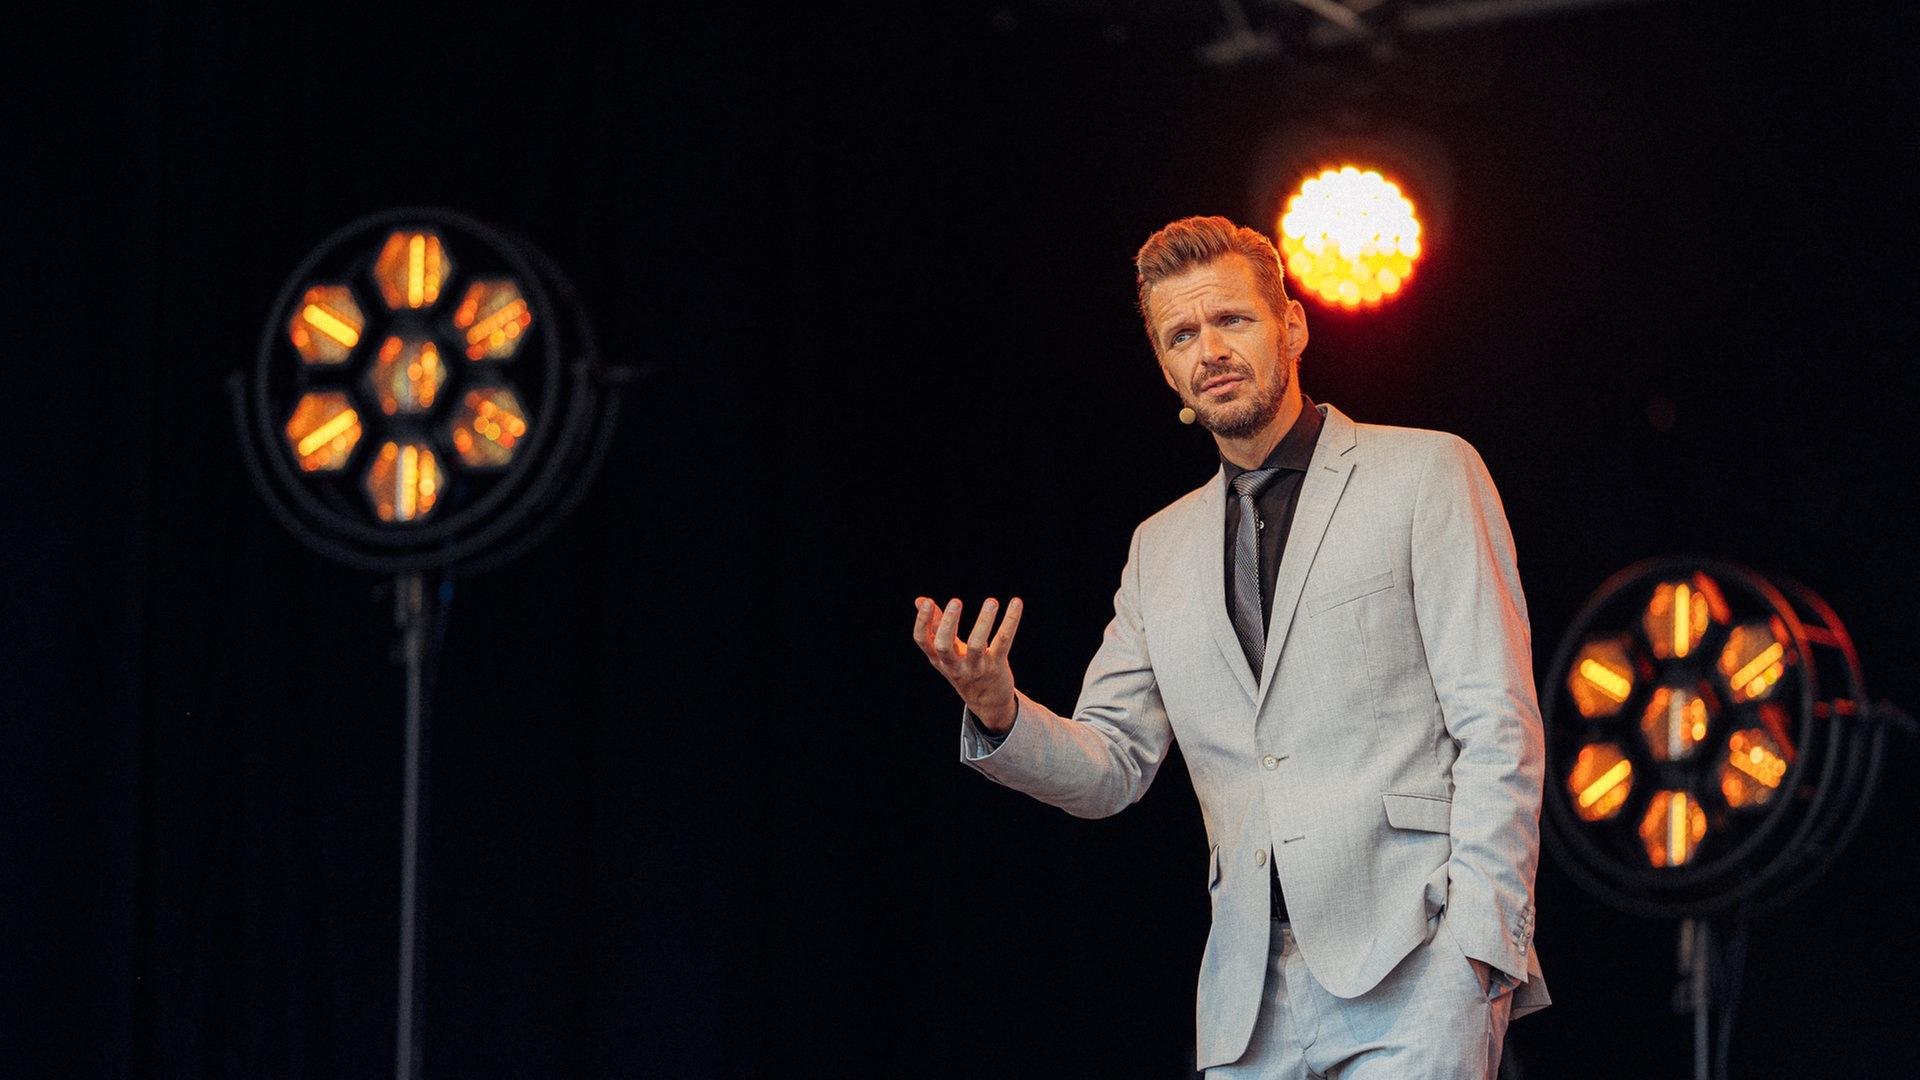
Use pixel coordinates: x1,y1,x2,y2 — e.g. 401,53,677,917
960,528,1173,817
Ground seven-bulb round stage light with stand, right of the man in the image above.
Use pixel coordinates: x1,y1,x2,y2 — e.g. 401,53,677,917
1542,557,1912,1080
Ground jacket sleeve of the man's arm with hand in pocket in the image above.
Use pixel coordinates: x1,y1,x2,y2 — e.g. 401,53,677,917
1413,440,1546,984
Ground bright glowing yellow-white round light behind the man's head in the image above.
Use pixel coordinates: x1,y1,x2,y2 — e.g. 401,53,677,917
1279,165,1421,307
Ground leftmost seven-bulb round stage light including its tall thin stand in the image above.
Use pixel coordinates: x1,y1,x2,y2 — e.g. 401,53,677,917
228,208,626,1080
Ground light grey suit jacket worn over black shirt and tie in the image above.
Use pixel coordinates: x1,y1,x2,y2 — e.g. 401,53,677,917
962,405,1546,1068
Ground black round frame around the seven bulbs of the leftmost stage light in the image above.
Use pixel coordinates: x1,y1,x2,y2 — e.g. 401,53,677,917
230,208,618,573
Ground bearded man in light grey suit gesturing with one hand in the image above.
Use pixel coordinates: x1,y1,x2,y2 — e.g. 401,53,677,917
914,217,1548,1080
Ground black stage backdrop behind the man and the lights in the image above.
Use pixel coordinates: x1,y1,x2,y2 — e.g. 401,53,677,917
15,0,1920,1080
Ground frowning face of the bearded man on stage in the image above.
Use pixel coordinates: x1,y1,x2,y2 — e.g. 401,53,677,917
1148,256,1306,438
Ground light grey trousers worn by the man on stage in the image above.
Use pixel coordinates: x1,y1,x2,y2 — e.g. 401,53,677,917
1206,915,1513,1080
